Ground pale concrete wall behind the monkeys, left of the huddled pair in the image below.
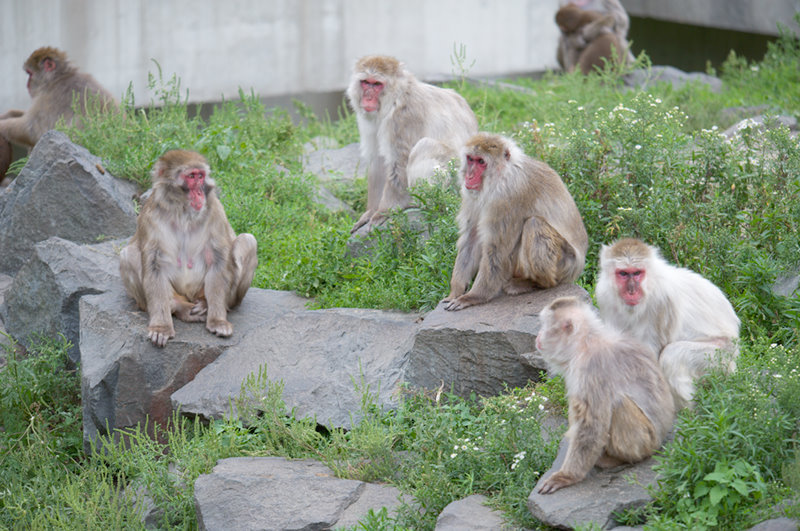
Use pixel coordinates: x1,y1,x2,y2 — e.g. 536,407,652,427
0,0,558,112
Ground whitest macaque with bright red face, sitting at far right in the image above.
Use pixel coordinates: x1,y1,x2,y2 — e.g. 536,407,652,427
595,238,739,409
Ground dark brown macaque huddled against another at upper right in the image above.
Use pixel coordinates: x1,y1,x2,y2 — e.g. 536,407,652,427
556,4,626,75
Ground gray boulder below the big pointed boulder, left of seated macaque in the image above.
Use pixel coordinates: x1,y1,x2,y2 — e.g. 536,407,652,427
0,237,125,364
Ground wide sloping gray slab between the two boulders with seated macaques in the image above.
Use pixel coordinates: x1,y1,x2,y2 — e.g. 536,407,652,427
172,308,418,428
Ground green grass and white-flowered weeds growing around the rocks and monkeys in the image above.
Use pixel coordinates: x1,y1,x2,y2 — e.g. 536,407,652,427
0,22,800,529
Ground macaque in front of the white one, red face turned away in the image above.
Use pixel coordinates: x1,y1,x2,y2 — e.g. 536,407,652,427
536,297,675,494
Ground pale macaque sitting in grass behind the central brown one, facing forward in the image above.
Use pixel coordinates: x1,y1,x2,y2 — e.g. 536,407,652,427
347,55,478,232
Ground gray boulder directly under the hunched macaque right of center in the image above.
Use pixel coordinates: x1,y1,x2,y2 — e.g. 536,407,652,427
406,284,589,396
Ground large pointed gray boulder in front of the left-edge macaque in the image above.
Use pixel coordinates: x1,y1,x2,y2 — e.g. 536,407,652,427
0,131,137,273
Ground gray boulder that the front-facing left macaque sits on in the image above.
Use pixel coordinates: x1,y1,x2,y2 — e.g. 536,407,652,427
80,285,305,450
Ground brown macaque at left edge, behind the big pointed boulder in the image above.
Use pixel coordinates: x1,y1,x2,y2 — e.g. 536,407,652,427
0,47,117,180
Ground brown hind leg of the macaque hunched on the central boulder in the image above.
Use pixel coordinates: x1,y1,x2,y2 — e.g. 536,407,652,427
512,216,576,289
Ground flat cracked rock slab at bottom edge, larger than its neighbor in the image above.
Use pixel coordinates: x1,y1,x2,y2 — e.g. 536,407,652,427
194,457,401,531
